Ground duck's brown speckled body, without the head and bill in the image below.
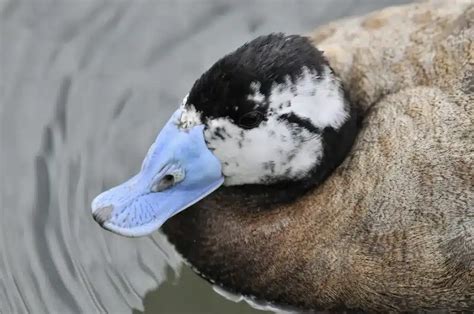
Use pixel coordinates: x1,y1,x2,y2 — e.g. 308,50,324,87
164,0,474,311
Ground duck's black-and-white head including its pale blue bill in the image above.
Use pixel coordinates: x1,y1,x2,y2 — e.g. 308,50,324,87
92,34,356,236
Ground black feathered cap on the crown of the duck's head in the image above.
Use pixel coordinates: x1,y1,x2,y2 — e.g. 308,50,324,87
185,33,328,128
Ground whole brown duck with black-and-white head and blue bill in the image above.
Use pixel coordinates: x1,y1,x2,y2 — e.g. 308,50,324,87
91,0,474,312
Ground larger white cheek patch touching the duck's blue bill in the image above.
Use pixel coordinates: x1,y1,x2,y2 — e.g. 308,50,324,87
204,116,323,185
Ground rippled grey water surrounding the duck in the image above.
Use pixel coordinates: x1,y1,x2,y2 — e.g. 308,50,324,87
0,0,407,313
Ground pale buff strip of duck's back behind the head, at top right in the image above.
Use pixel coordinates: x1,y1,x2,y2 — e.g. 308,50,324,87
310,0,474,110
